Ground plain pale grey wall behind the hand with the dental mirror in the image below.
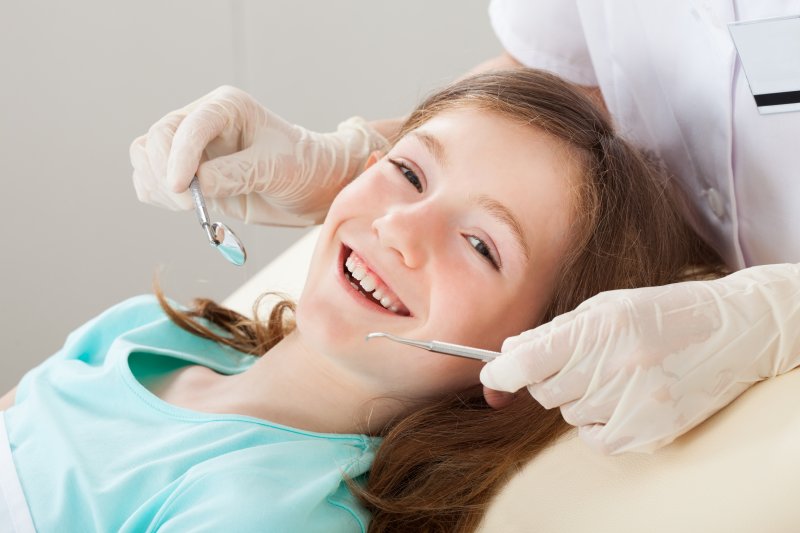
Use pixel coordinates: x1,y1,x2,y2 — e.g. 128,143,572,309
0,0,500,395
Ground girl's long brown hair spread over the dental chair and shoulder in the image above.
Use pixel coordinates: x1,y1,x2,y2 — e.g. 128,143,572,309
157,69,724,532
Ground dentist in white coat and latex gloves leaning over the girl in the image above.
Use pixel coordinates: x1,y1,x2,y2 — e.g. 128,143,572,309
131,0,800,453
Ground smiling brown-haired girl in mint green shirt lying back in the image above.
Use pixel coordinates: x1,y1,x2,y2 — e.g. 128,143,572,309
0,70,720,532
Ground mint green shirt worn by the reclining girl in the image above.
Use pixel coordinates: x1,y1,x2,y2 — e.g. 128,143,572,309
0,296,379,533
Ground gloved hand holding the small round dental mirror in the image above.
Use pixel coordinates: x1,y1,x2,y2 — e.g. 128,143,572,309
130,86,386,225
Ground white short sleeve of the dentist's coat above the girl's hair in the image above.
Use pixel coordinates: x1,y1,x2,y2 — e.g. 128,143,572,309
489,0,598,86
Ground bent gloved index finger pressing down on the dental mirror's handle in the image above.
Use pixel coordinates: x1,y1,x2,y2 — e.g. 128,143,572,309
166,101,235,192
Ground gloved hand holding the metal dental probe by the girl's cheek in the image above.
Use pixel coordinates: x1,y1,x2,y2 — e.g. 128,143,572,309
481,264,800,453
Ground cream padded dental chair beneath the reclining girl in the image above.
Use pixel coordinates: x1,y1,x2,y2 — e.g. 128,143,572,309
224,229,800,533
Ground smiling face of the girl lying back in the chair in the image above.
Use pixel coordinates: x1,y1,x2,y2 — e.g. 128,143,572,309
297,107,579,400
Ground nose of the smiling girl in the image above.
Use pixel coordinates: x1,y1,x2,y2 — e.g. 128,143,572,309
372,203,445,268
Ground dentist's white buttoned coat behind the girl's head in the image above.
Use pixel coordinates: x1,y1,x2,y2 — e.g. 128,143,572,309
489,0,800,268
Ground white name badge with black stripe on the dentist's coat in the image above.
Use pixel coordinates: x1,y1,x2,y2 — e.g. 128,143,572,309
728,13,800,115
